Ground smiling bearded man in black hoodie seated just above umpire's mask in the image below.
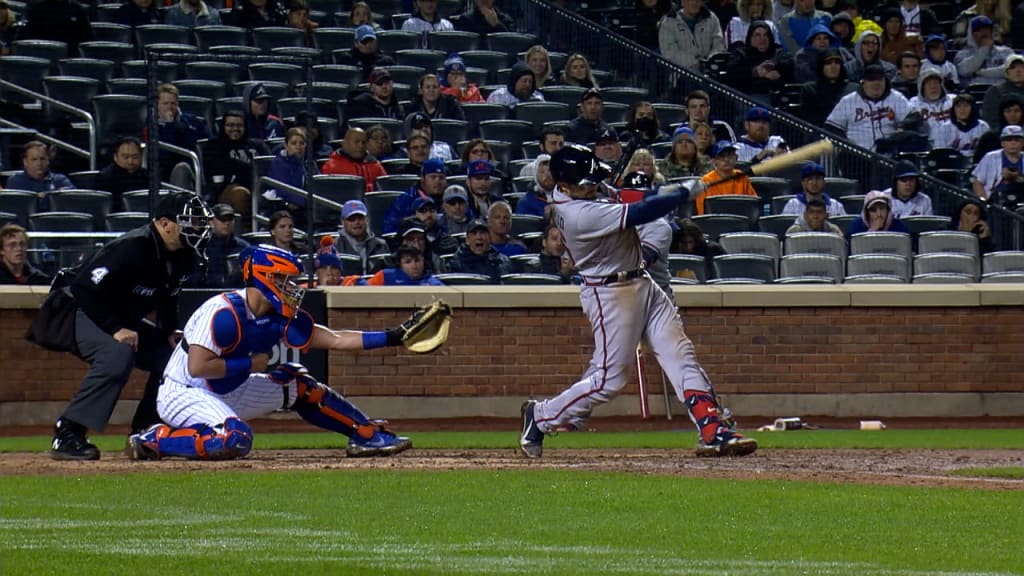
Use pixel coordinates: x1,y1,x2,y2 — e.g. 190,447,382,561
203,111,270,216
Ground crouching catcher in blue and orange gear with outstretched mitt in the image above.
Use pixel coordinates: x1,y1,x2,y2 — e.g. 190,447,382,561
126,244,452,460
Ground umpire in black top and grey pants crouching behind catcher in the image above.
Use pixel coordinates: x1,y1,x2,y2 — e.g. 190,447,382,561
50,193,210,460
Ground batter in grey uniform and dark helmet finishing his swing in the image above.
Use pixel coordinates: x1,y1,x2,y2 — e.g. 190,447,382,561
519,145,758,458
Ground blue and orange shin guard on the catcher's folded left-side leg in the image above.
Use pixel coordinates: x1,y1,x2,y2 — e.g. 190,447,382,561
150,417,253,460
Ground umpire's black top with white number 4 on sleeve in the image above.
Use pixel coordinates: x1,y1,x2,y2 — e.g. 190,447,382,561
71,222,197,335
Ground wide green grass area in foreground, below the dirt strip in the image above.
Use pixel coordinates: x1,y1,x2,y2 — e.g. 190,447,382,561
0,469,1024,576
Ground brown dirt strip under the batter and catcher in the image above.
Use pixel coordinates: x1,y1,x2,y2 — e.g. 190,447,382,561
0,448,1024,490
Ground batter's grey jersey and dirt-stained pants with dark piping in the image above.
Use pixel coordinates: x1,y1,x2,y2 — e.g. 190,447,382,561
534,188,711,433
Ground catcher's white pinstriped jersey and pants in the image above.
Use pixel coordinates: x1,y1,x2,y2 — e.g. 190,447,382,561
157,289,295,428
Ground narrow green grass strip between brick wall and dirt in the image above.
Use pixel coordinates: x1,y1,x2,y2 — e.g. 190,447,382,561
0,426,1024,452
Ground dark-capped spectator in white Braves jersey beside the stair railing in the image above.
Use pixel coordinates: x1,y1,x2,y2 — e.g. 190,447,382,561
825,65,910,150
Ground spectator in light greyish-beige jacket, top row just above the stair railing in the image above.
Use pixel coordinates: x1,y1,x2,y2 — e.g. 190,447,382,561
657,0,725,71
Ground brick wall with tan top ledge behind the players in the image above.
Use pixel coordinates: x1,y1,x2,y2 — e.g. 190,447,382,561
0,284,1024,424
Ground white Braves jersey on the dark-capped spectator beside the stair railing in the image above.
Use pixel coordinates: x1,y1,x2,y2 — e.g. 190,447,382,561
825,88,910,150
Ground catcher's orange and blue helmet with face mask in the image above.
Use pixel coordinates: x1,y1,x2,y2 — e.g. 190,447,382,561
239,244,306,318
